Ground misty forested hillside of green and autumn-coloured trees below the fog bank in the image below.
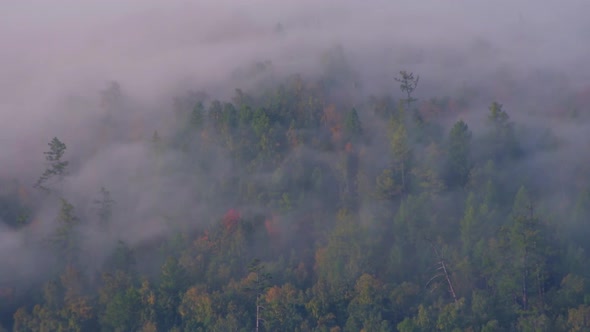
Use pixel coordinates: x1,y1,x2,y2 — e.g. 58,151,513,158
0,61,590,332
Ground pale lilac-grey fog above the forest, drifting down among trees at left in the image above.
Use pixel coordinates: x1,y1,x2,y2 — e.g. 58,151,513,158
0,0,590,286
